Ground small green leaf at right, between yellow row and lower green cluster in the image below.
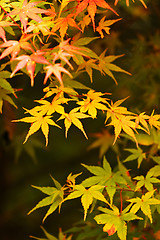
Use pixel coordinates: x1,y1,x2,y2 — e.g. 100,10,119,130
124,148,146,168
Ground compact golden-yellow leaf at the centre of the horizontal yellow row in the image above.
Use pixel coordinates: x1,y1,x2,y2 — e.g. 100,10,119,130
77,90,107,118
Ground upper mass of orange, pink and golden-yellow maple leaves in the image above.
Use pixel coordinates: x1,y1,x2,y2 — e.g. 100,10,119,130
0,1,160,146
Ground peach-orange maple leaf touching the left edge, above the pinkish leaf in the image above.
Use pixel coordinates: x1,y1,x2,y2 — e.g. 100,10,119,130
0,34,34,60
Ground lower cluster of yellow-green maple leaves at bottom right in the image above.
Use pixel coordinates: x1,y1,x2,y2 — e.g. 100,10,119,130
29,158,160,240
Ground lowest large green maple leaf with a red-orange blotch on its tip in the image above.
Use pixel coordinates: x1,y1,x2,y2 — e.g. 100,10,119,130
94,206,141,240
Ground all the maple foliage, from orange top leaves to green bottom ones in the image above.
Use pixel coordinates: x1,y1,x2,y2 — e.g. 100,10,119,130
0,0,160,240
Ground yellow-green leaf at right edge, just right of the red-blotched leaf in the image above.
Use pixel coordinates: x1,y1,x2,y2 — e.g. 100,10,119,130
127,190,160,223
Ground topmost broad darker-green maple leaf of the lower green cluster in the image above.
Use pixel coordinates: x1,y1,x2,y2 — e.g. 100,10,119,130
82,157,127,204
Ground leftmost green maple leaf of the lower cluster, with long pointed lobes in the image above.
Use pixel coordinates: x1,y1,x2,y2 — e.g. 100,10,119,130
28,177,64,222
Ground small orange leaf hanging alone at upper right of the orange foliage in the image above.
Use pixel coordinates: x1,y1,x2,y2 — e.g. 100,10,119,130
96,16,122,38
